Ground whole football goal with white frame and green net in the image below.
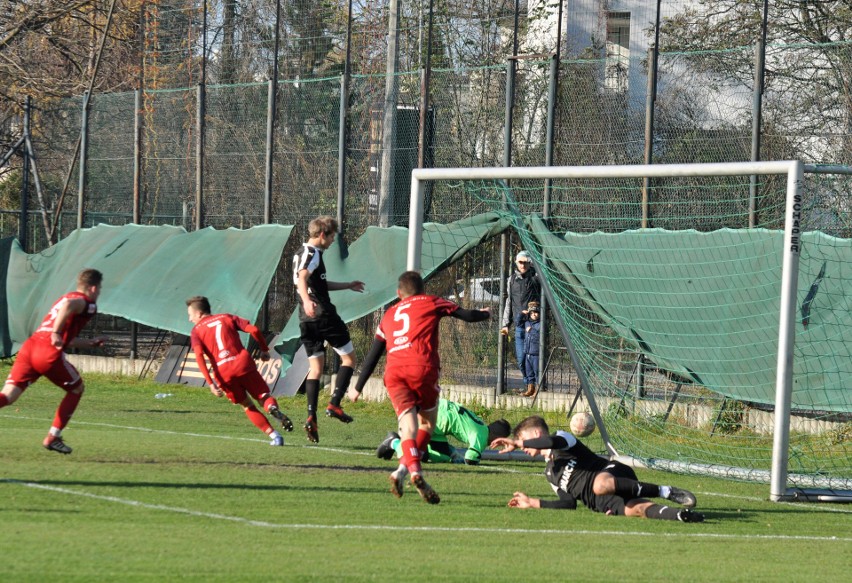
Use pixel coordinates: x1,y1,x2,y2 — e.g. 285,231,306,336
408,161,852,501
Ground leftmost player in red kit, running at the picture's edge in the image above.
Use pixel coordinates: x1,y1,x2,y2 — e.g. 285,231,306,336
0,269,105,454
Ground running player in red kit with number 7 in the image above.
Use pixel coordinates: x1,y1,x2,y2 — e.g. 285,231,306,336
186,296,293,445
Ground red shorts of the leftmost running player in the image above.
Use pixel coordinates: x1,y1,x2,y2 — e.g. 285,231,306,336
6,336,83,391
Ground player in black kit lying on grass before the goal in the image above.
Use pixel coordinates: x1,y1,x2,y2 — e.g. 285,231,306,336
491,415,704,522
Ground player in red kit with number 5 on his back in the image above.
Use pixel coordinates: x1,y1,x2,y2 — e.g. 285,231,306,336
349,271,491,504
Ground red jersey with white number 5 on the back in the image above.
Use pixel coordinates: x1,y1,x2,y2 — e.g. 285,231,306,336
376,294,459,368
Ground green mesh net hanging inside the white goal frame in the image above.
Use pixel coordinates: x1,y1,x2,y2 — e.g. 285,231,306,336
465,171,852,487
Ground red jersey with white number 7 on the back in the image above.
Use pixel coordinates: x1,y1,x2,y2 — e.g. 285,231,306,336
189,314,257,382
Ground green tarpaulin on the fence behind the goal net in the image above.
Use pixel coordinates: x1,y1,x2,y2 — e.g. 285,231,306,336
530,218,852,411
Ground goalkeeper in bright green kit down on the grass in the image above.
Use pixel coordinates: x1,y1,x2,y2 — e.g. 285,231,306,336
376,399,511,465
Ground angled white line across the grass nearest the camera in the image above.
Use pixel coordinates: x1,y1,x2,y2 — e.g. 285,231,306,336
0,479,852,542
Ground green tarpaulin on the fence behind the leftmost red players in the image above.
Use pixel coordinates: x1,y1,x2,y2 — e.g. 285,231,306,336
0,225,293,356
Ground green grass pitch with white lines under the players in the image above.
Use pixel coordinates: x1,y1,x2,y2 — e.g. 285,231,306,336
0,372,852,583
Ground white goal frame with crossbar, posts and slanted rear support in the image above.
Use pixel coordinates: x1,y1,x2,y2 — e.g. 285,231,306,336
407,160,820,501
